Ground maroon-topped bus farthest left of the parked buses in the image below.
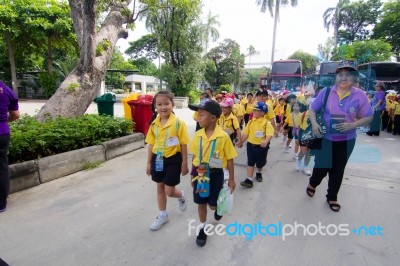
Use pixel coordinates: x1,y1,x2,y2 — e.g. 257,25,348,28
268,59,303,91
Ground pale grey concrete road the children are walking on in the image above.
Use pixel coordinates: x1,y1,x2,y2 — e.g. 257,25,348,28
0,102,400,266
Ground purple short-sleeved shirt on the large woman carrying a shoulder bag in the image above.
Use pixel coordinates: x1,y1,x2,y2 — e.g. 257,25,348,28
311,85,373,141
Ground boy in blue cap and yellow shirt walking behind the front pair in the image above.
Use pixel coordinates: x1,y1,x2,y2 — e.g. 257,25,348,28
236,102,274,188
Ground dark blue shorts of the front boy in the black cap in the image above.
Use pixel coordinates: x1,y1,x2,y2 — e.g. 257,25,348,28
193,168,224,206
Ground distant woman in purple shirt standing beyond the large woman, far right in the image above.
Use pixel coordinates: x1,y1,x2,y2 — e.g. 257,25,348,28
367,82,386,136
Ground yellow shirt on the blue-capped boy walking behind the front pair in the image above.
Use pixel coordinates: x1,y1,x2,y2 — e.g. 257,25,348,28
243,116,275,145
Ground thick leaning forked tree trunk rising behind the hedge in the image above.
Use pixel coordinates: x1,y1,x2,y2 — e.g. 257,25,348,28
36,0,132,121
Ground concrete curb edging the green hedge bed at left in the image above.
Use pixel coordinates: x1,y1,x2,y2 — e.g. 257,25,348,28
9,133,144,193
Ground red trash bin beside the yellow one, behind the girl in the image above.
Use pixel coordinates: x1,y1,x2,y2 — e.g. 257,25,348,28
128,100,153,135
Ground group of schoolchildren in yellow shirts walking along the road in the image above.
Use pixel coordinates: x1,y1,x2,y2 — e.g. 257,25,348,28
145,89,311,247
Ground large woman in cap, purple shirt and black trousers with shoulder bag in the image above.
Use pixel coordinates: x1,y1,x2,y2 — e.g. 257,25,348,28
306,61,373,212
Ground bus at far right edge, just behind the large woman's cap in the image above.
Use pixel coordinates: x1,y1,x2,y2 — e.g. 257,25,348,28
358,62,400,91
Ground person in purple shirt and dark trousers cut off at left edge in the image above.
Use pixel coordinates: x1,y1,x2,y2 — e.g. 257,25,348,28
0,81,20,212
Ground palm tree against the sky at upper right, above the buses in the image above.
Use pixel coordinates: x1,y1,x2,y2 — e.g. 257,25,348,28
322,0,350,47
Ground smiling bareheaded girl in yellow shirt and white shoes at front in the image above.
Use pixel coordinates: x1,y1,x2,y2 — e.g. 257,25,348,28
145,91,189,231
